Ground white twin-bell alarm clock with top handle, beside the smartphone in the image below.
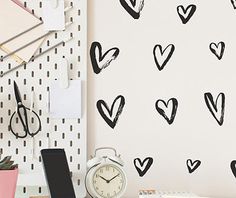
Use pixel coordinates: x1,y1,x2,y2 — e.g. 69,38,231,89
85,147,127,198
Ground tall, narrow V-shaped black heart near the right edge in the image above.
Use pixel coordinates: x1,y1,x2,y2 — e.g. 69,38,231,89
204,92,225,126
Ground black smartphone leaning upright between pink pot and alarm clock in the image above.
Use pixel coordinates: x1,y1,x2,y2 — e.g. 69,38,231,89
41,149,76,198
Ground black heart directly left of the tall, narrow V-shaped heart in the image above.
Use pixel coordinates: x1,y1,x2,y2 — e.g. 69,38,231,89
156,98,178,124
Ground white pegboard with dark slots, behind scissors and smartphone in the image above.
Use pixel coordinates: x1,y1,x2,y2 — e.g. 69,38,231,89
0,0,87,198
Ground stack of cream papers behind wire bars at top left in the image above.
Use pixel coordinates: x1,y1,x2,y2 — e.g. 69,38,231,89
0,0,45,63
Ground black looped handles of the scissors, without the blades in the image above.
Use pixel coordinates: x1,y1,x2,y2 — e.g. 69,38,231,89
9,104,41,138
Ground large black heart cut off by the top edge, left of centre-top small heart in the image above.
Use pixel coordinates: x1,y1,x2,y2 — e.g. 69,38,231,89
120,0,144,19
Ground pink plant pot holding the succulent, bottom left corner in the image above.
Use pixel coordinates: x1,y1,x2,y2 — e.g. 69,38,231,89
0,169,18,198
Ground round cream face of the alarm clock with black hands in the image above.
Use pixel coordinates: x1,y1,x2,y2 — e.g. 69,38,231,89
93,164,126,198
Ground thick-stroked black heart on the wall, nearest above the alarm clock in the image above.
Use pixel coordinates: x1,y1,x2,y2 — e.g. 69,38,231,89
97,95,125,129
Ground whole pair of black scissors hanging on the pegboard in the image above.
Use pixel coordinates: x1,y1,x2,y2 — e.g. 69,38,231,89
9,81,41,138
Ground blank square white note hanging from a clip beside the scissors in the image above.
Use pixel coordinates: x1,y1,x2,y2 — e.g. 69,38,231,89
50,80,81,118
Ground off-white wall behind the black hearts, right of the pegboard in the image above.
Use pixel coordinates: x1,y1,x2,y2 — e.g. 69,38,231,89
88,0,236,197
